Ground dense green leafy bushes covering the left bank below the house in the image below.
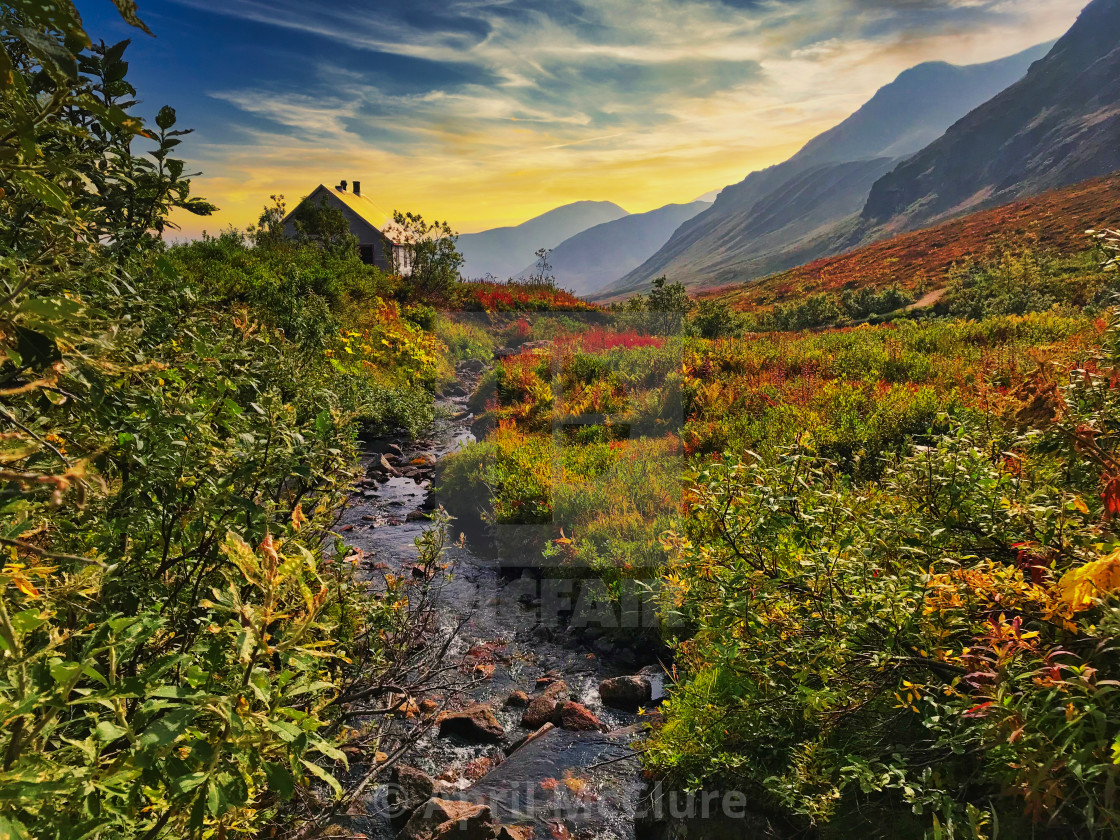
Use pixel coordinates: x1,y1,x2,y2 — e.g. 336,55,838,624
0,9,438,840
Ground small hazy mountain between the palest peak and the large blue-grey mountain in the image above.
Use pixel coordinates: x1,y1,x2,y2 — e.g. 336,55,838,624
520,200,711,295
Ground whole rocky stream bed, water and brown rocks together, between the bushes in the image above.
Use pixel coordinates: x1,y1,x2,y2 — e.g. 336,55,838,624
329,363,662,840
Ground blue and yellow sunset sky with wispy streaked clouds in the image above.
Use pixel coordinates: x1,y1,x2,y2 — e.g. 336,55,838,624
77,0,1088,236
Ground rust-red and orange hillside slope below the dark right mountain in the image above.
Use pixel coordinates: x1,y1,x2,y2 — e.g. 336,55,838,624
706,174,1120,309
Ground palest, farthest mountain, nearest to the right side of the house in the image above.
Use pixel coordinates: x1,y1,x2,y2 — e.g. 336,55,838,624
458,202,626,280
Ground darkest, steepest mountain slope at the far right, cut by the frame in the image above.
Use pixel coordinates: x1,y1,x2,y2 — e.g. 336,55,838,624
862,0,1120,232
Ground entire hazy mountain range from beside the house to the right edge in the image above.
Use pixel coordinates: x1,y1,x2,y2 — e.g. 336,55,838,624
459,0,1120,300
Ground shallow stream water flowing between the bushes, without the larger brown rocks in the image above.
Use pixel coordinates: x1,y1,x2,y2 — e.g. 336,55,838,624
339,363,661,840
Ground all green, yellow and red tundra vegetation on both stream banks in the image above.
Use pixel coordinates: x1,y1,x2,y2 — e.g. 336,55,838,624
0,0,1120,840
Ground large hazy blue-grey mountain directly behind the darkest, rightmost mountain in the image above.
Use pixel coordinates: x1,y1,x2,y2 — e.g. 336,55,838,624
601,45,1051,297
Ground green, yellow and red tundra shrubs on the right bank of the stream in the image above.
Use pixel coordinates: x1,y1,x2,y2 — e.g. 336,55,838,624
442,249,1120,838
